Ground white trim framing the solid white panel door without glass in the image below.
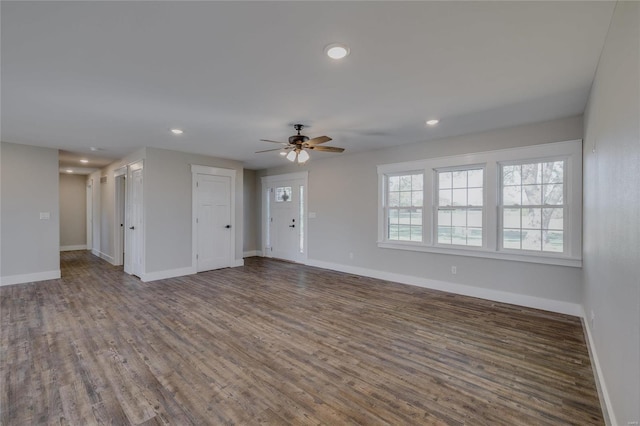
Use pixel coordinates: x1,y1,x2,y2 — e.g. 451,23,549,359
191,164,237,271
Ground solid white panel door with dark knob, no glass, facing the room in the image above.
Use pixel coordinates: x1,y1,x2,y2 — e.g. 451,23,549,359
196,174,234,272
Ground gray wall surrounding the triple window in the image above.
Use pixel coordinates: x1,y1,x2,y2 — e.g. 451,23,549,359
257,117,583,306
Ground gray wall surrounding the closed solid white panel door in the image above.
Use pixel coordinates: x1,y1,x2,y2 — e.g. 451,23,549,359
143,148,244,273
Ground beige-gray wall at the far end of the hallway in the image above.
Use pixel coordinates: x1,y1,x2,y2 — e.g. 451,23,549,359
60,173,87,249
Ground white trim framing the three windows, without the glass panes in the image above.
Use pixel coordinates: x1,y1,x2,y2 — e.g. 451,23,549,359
377,139,582,267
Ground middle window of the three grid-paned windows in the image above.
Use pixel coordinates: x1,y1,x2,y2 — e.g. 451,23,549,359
436,168,484,247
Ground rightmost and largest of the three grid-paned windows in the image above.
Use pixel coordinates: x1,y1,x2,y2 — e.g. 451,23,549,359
501,160,565,253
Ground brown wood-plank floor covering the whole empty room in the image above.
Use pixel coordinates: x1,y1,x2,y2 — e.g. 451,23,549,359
0,252,603,425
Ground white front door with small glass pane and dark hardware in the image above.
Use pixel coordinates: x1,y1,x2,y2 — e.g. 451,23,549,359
267,179,306,262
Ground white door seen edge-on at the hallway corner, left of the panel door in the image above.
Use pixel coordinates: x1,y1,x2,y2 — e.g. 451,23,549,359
124,161,144,277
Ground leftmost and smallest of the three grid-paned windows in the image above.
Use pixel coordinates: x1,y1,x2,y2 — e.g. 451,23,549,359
386,173,424,241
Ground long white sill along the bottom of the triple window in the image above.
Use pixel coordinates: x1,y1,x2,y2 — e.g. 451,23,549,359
378,241,582,268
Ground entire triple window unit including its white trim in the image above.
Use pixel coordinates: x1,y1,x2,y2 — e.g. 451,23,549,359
378,140,582,267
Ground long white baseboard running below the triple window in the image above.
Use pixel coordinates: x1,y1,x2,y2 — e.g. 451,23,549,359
306,259,583,317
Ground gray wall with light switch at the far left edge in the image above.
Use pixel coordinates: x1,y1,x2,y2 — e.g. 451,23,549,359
0,142,60,284
